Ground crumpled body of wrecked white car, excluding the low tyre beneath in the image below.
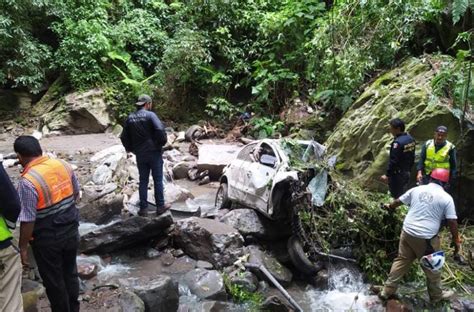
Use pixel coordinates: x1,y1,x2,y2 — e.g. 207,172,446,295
216,139,327,220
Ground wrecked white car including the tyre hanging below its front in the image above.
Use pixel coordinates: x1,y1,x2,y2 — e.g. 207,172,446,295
216,139,353,275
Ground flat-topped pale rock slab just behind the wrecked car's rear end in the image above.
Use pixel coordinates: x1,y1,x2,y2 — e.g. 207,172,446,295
197,144,241,180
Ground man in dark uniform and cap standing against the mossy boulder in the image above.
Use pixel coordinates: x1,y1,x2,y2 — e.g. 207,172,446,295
381,118,415,198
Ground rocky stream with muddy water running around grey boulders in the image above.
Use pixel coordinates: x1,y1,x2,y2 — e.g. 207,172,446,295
0,130,383,311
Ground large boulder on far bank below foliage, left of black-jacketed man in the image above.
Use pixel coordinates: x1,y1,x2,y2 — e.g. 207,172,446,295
41,89,115,134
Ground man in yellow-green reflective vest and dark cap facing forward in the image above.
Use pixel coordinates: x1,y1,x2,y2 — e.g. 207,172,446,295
416,126,456,189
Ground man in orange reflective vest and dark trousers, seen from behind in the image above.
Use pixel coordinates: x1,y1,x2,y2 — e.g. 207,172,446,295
13,136,80,312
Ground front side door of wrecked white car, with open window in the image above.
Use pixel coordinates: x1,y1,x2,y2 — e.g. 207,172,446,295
242,142,280,213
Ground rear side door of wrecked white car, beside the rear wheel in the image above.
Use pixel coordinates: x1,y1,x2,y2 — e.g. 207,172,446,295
227,143,257,204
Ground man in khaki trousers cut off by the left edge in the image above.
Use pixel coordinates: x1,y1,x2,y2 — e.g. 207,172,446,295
0,161,23,311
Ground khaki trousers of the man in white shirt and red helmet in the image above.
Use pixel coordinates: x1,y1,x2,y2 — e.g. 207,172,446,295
384,231,442,300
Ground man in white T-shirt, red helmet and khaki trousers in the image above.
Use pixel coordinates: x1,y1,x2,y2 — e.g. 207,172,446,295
379,168,461,303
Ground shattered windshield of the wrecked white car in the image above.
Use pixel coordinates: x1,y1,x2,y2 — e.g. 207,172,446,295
279,139,326,168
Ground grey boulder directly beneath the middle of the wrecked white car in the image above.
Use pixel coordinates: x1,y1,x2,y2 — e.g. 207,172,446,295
219,209,290,240
